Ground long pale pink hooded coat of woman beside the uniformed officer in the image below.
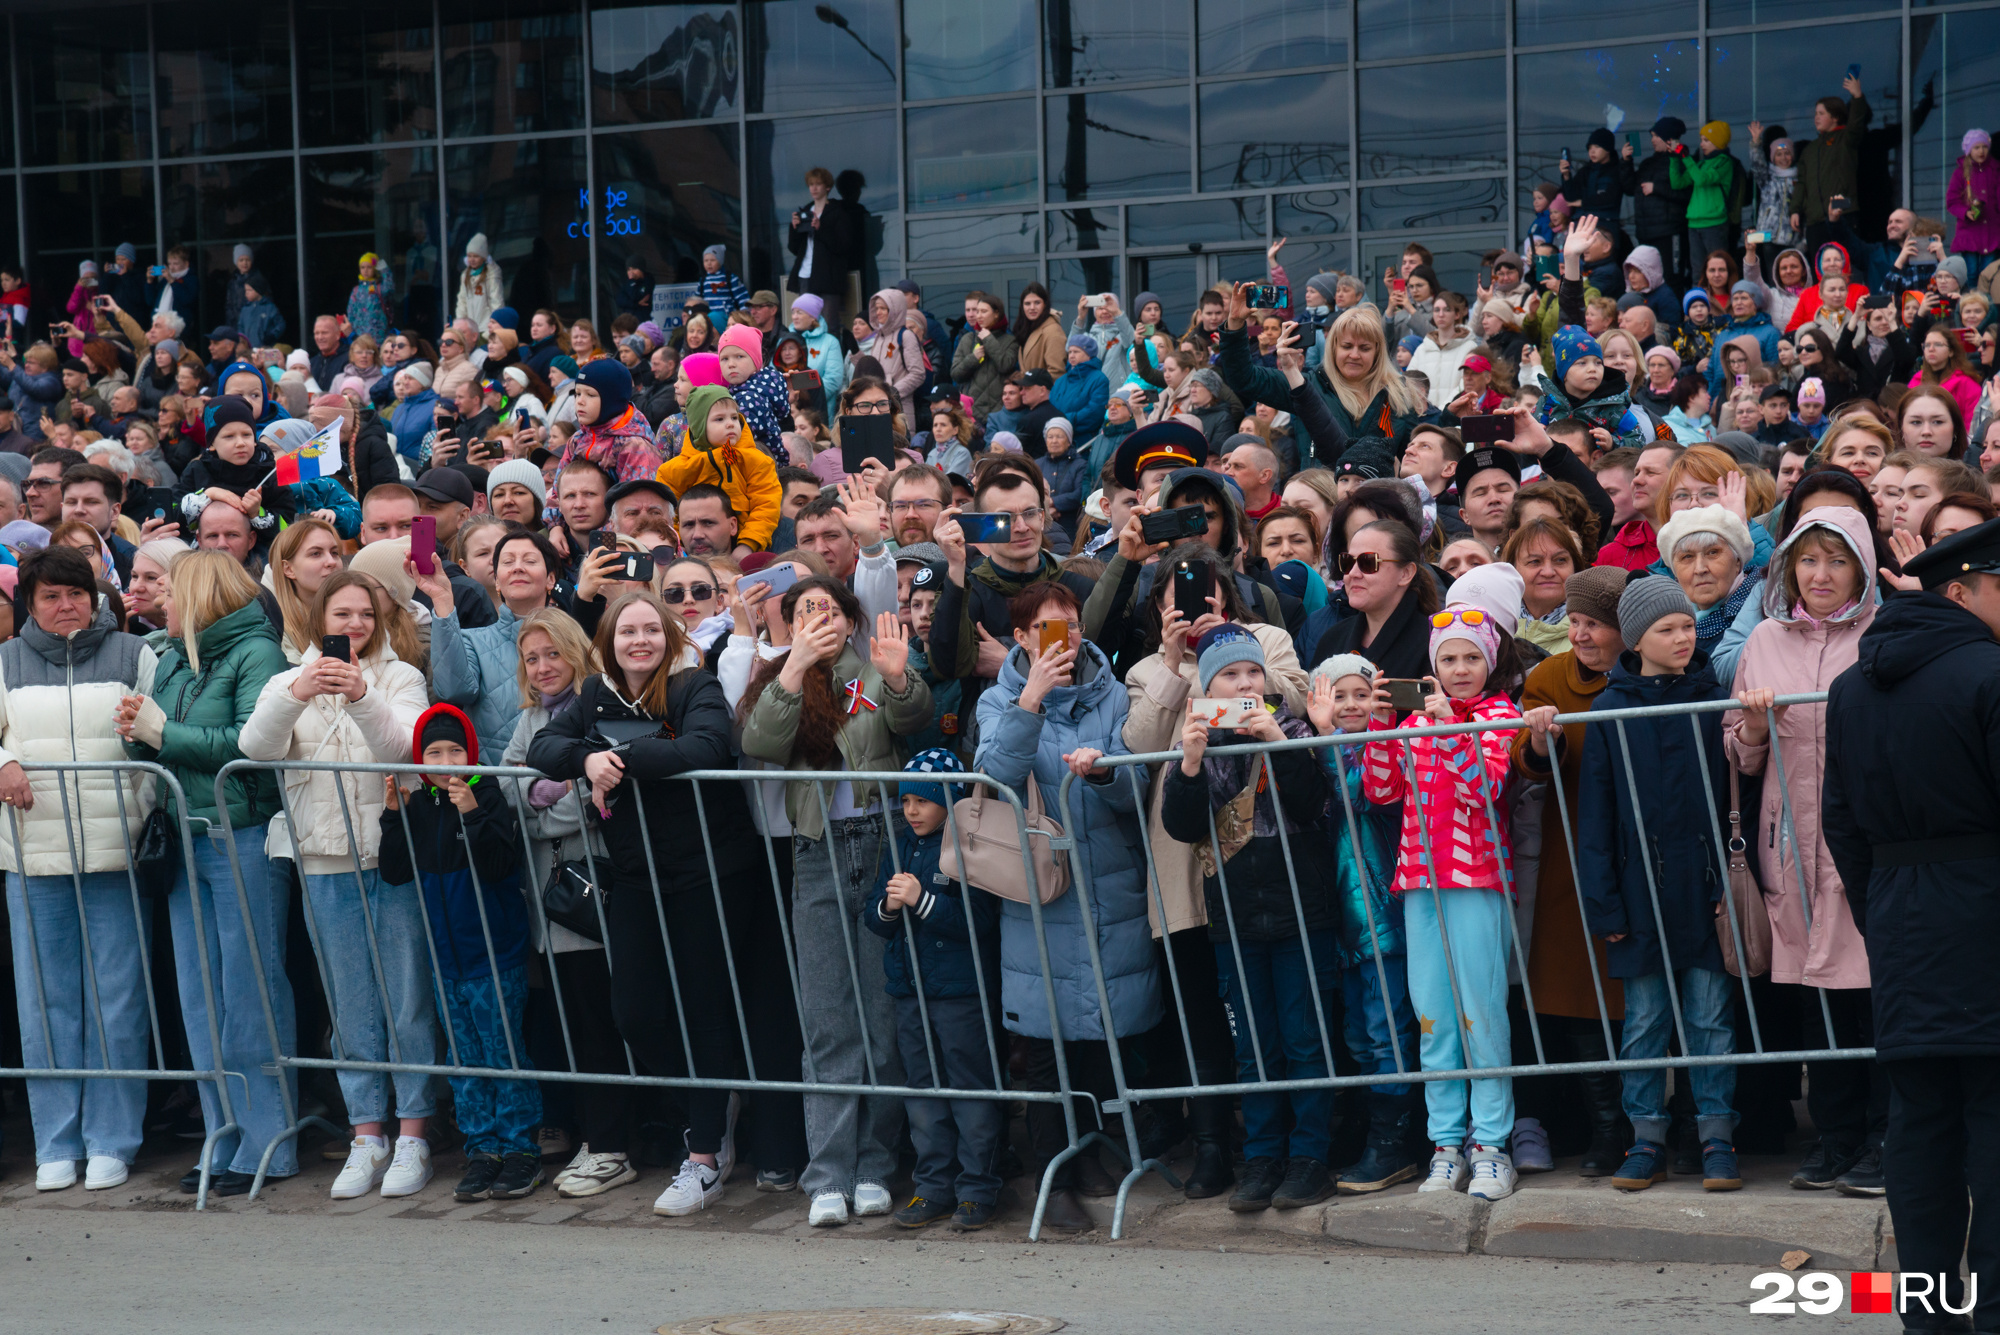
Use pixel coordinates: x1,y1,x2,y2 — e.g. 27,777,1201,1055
1722,506,1876,987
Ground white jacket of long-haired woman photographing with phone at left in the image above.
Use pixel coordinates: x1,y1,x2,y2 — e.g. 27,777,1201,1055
236,644,430,875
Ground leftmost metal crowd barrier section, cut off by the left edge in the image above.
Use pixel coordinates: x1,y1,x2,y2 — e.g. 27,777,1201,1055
0,759,242,1209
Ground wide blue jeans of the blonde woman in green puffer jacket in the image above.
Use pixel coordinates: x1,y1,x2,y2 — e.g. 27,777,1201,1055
166,825,298,1177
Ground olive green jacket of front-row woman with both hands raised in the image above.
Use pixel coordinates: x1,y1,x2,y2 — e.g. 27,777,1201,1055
742,646,930,839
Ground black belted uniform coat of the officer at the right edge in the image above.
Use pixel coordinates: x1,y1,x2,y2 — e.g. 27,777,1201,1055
1820,594,2000,1061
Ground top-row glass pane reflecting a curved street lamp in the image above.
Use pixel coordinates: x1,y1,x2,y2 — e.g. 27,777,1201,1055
744,0,900,112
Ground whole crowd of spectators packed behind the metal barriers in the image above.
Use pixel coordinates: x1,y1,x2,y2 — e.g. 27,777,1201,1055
0,111,2000,1279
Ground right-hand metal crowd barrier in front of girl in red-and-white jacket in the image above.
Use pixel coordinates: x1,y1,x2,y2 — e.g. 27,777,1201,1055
1056,691,1874,1239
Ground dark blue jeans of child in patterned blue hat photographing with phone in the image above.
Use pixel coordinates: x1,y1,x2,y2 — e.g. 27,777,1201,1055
1214,927,1340,1163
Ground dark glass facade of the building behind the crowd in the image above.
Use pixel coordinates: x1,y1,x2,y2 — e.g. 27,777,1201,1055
11,0,2000,342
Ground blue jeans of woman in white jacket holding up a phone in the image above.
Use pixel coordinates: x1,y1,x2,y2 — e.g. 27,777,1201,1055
306,869,438,1123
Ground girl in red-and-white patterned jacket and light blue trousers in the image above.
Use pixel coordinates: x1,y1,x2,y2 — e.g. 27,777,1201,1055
1362,604,1520,1201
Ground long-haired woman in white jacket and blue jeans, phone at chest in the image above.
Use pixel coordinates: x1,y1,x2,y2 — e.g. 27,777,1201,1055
236,570,438,1201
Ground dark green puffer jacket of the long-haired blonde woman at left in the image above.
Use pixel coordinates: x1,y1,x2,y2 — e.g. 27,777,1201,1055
126,604,292,833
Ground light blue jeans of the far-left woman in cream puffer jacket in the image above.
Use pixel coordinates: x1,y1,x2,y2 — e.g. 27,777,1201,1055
6,871,152,1163
